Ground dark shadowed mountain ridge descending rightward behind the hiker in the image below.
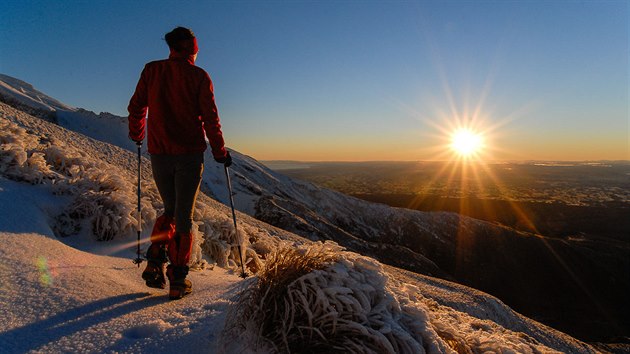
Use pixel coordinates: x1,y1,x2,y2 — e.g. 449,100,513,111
1,73,630,344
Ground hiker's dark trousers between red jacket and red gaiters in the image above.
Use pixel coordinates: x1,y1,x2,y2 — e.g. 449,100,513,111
151,153,203,233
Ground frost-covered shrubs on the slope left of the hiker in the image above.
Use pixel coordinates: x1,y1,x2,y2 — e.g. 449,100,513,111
0,119,156,240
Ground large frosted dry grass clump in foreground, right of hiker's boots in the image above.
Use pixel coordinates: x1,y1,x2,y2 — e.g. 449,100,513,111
220,243,453,354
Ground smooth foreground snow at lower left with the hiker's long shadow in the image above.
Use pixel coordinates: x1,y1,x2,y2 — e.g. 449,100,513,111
0,178,240,353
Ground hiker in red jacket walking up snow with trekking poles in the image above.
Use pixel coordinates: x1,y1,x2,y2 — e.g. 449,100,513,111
128,27,232,299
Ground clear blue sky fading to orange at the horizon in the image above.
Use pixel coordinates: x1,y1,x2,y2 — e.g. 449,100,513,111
0,0,630,160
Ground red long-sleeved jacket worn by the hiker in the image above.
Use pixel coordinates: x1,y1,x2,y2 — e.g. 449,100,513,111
127,52,227,158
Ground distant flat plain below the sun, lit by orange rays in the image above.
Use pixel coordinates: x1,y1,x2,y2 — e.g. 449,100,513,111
266,161,630,242
